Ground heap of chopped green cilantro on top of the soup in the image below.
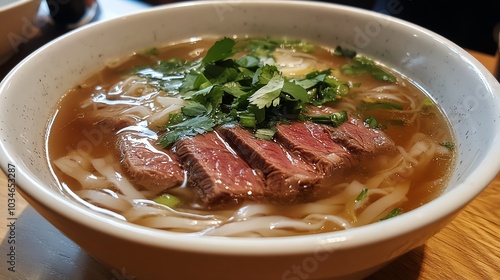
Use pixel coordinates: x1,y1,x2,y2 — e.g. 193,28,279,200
135,38,360,146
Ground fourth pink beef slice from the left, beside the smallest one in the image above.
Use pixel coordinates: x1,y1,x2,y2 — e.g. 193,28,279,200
276,122,357,177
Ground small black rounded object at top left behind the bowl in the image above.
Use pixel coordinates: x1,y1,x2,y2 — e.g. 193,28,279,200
47,0,87,26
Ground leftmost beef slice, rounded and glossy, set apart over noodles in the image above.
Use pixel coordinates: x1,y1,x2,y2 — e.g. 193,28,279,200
117,132,184,193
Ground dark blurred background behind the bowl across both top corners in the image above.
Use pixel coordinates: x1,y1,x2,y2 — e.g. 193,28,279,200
0,0,500,79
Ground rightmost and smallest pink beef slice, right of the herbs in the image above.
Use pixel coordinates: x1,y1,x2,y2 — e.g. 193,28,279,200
325,118,395,156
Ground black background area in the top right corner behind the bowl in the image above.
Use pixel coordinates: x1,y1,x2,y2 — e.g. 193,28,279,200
325,0,500,55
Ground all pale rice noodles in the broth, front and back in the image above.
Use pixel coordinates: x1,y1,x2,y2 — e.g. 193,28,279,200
49,38,451,237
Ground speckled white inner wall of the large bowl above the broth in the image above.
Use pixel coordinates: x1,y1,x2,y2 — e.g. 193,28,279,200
0,1,500,250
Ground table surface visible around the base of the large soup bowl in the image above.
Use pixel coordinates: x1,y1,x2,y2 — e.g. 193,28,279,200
0,0,500,280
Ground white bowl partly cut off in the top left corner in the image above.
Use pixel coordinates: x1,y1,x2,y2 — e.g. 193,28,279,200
0,0,40,65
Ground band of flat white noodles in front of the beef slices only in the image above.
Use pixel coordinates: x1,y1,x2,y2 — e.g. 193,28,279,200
51,112,442,236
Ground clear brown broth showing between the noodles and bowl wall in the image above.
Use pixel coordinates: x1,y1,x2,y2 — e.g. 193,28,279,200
47,39,454,234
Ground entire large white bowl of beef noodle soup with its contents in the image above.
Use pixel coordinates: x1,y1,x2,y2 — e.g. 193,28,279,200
0,1,500,279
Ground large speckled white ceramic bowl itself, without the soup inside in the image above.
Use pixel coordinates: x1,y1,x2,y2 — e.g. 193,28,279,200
0,1,500,280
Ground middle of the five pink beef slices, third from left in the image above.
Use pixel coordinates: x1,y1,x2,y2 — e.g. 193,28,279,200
217,125,321,202
